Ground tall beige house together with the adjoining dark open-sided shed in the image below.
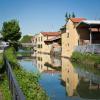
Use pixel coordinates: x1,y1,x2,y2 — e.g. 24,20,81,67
61,18,100,57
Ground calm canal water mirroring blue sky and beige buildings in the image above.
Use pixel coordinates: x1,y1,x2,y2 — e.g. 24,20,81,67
19,54,100,100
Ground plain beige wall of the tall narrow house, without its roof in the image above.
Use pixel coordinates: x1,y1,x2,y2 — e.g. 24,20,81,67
61,20,79,57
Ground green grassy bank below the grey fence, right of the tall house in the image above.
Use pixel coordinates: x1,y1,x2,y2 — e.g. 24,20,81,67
71,52,100,66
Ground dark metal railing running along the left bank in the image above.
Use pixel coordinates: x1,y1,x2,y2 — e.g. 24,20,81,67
4,57,26,100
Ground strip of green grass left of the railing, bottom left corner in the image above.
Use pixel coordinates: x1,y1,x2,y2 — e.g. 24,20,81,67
0,75,11,100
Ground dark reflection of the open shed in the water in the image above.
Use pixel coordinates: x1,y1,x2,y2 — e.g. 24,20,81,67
76,77,100,99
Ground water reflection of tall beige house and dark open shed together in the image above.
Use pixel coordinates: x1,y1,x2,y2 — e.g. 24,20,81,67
61,58,100,100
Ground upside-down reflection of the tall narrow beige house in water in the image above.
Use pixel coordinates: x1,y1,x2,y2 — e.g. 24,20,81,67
61,58,79,96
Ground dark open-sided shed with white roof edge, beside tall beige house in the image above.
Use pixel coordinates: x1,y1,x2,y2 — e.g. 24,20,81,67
76,20,100,45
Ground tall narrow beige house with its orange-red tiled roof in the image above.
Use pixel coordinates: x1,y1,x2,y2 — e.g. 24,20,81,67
60,18,86,57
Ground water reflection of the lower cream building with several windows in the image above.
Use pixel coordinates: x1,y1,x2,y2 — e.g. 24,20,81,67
36,54,61,73
